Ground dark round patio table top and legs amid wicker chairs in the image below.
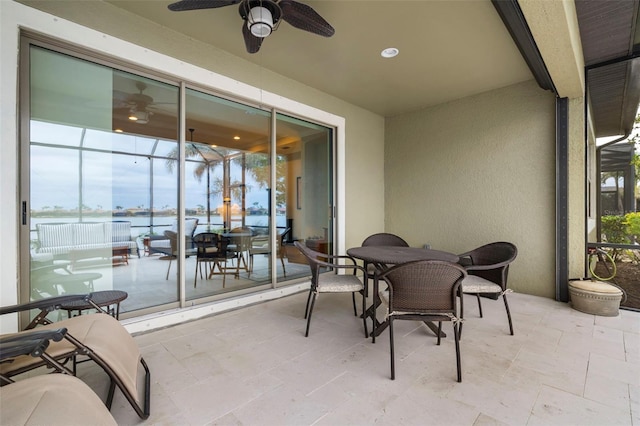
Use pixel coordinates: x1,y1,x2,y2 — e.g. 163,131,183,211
347,246,459,337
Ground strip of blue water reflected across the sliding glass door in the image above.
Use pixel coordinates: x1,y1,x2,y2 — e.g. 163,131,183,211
31,215,287,239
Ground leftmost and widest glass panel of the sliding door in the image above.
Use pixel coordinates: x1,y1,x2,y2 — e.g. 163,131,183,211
25,46,178,313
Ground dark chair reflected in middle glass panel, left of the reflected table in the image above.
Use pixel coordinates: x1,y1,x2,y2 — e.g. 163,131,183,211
193,232,238,288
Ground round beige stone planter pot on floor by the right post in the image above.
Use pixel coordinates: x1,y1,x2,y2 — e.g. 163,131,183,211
569,280,622,317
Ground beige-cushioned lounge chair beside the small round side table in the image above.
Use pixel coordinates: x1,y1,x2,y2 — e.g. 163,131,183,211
0,294,151,419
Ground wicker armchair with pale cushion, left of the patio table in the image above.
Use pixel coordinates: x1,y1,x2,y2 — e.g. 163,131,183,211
294,241,369,337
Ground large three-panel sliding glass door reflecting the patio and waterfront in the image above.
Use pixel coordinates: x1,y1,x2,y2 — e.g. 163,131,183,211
20,37,334,316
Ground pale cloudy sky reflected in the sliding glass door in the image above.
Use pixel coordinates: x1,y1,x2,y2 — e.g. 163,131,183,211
29,121,268,210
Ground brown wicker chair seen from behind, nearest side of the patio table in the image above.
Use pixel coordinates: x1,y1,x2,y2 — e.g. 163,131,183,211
373,260,467,382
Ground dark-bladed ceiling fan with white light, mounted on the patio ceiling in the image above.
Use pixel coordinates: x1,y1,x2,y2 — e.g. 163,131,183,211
169,0,335,53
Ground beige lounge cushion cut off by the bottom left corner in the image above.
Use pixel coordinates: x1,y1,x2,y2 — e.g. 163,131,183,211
0,374,117,426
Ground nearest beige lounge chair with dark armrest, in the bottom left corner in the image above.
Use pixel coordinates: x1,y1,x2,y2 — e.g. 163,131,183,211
0,328,116,426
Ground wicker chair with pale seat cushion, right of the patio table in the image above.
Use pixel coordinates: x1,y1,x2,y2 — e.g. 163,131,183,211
459,241,518,335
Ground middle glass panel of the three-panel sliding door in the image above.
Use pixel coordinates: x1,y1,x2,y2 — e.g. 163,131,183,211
185,89,271,299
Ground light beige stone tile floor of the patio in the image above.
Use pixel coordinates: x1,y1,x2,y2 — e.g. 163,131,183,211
80,293,640,425
